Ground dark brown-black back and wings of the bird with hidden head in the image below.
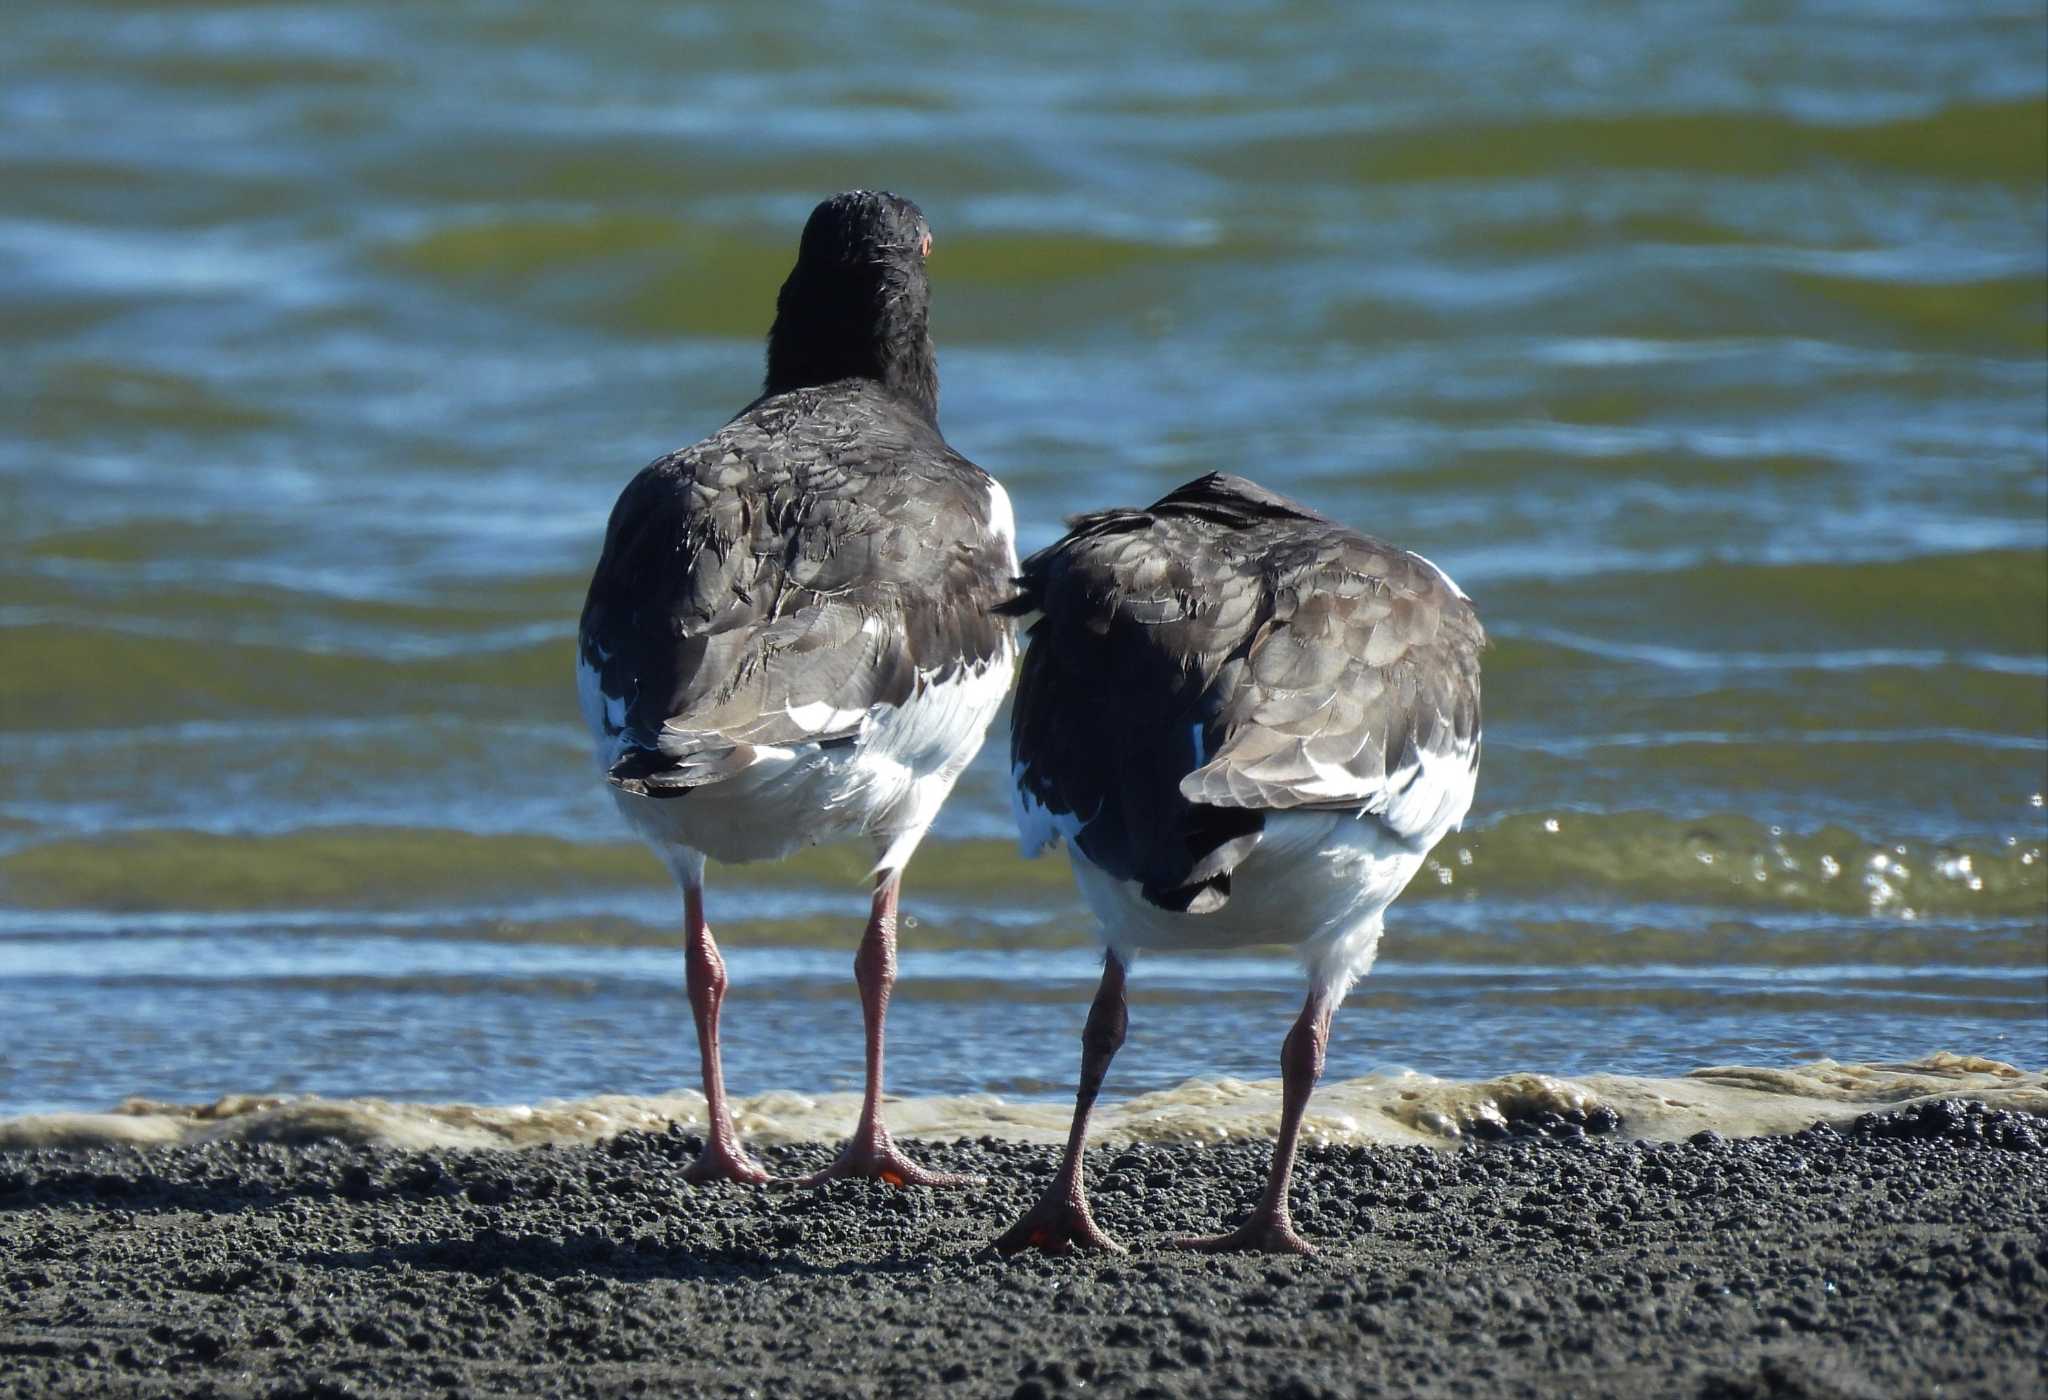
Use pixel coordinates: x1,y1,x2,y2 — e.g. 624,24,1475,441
1012,475,1485,913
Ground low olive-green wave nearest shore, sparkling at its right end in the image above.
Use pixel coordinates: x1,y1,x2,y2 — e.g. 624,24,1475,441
0,811,2048,925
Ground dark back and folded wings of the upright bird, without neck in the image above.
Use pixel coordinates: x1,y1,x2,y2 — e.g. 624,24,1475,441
580,405,1010,796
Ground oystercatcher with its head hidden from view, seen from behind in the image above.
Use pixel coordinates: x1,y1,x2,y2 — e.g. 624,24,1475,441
997,475,1485,1253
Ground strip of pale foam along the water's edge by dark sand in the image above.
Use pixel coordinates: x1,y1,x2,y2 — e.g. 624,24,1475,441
0,1054,2048,1150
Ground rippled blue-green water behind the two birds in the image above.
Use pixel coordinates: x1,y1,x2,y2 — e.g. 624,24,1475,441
0,0,2048,1111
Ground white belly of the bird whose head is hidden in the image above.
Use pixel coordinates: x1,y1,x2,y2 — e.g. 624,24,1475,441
1067,813,1427,995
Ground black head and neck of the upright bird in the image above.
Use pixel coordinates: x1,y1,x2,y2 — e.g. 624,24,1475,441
768,190,938,424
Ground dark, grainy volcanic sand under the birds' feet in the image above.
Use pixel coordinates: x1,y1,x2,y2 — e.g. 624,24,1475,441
0,1105,2048,1396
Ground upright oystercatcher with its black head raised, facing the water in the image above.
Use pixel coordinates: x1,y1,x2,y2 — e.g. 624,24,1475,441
578,190,1016,1185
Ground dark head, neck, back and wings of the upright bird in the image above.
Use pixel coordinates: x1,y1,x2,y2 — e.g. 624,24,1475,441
580,190,1010,796
